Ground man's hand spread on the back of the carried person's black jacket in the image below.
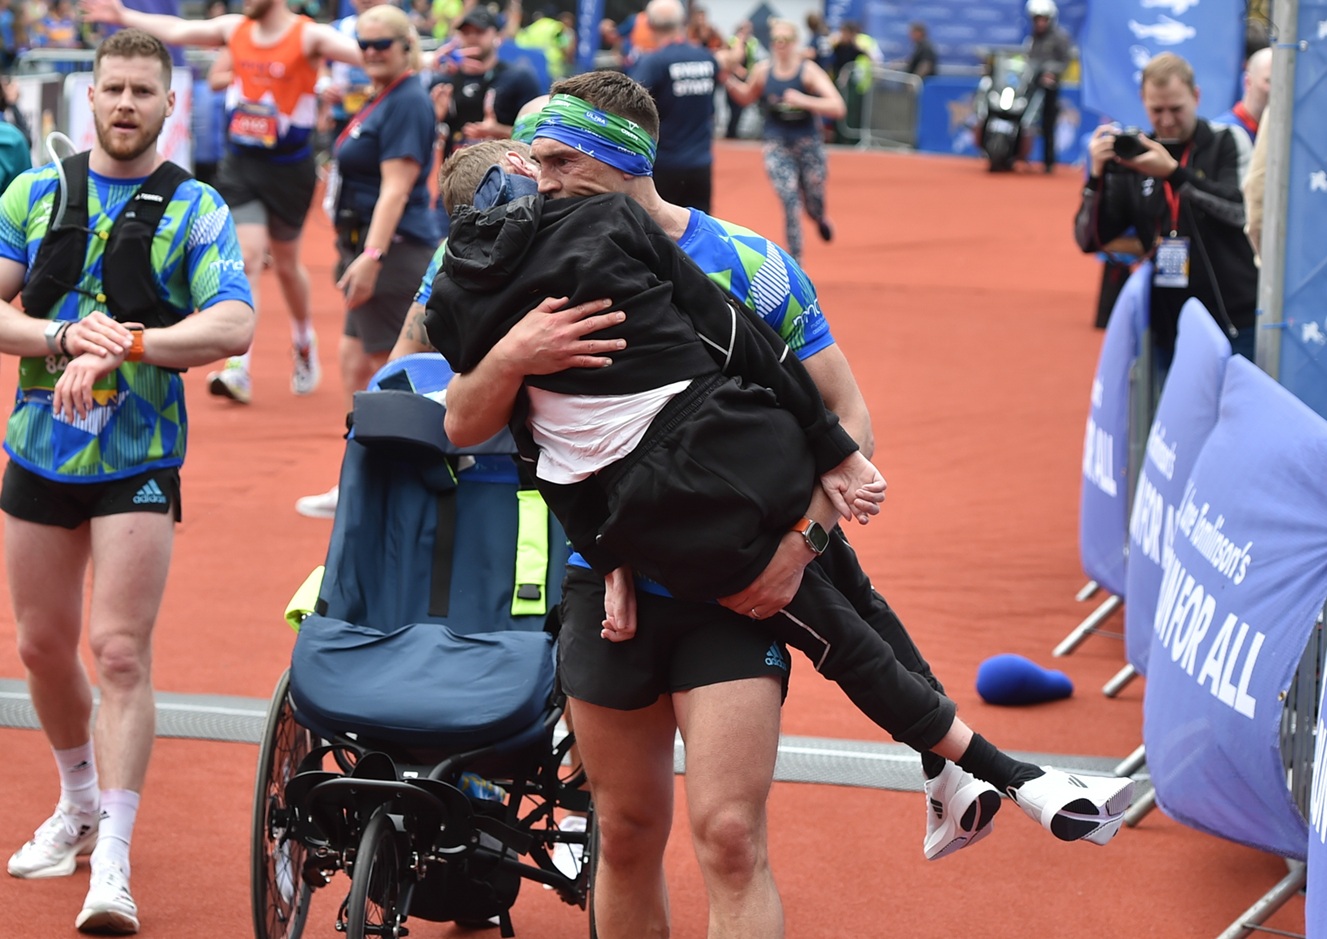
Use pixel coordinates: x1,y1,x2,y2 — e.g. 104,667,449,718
490,297,626,375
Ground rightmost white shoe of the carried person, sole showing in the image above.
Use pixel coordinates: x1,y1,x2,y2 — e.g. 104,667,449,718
1009,767,1133,845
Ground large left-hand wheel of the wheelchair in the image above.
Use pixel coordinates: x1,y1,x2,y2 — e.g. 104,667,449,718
249,671,313,939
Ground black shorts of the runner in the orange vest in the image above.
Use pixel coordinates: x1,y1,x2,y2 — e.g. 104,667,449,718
216,150,318,241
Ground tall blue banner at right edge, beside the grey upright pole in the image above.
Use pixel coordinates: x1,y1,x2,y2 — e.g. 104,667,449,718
1273,0,1327,416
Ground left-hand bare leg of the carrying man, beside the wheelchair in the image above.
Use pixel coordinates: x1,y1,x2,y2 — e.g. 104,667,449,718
571,698,677,939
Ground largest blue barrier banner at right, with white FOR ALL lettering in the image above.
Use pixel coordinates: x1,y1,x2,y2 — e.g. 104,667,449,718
1143,355,1327,859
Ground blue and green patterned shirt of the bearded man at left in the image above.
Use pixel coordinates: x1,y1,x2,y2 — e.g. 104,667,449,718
0,163,253,483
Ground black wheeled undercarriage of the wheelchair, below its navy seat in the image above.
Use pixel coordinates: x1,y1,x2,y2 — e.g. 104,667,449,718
249,671,598,939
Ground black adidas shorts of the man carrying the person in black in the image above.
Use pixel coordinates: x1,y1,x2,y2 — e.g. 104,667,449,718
557,566,790,711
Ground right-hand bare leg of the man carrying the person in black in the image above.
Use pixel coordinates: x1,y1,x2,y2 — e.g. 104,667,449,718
673,678,783,939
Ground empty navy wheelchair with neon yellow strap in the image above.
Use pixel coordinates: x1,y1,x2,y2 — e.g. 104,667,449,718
251,355,597,939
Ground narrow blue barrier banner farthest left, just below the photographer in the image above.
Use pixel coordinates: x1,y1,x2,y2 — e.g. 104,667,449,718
1079,261,1152,597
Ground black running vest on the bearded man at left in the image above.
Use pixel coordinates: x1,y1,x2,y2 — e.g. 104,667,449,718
23,150,192,328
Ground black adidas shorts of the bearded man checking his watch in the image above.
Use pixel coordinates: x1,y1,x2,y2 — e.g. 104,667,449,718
0,460,180,531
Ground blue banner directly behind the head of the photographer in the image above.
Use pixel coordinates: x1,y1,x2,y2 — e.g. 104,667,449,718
1079,0,1246,130
